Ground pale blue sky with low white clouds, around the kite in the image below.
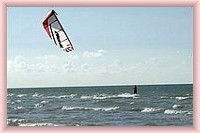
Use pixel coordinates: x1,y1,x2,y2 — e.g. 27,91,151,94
7,7,193,88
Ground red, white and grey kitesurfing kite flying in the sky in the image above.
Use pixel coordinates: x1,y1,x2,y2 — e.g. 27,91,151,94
43,10,74,52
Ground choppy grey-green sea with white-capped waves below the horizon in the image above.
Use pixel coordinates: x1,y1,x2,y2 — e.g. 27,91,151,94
7,84,193,126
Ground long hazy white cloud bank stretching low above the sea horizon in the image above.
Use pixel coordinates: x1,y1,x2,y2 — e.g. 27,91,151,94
8,49,192,86
